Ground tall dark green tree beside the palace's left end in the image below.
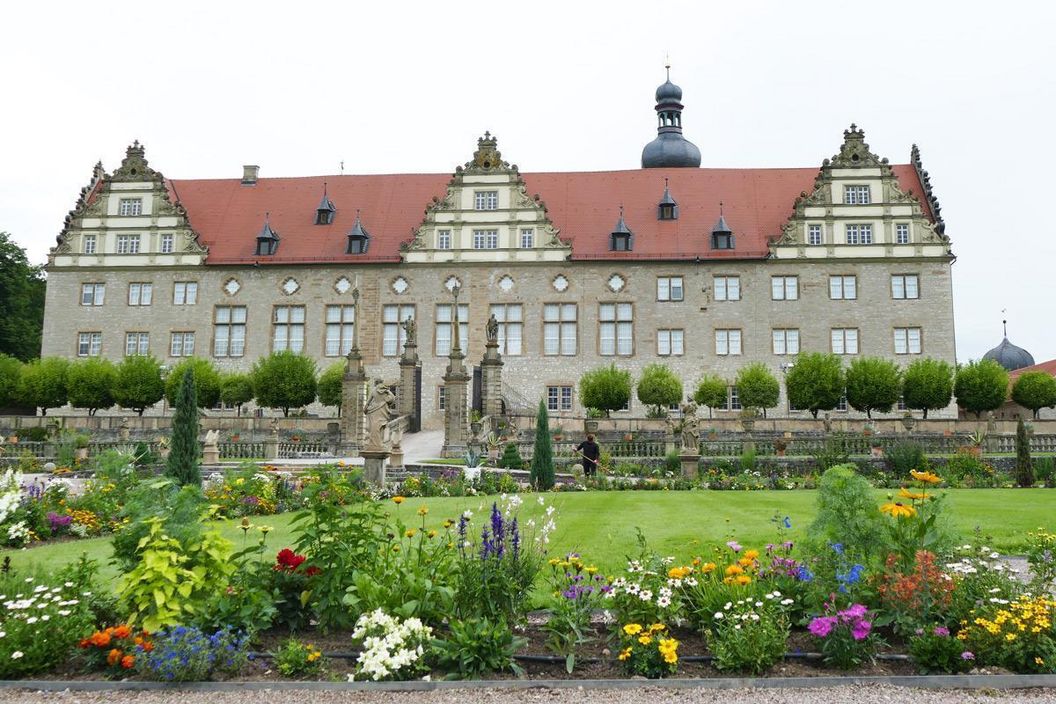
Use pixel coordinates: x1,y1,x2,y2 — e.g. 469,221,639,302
0,232,44,360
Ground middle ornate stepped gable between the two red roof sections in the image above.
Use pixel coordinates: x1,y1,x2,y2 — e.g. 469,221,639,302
400,132,571,262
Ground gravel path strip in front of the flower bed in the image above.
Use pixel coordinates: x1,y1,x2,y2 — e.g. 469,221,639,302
0,686,1056,704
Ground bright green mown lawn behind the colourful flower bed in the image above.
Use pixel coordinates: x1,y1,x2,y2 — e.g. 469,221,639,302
2,489,1056,575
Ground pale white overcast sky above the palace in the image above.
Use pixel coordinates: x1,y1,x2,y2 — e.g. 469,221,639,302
0,0,1056,362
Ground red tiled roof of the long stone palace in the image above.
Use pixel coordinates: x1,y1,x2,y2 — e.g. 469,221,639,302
169,165,930,264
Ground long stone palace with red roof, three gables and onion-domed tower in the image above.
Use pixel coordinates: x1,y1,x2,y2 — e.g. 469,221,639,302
42,72,956,427
